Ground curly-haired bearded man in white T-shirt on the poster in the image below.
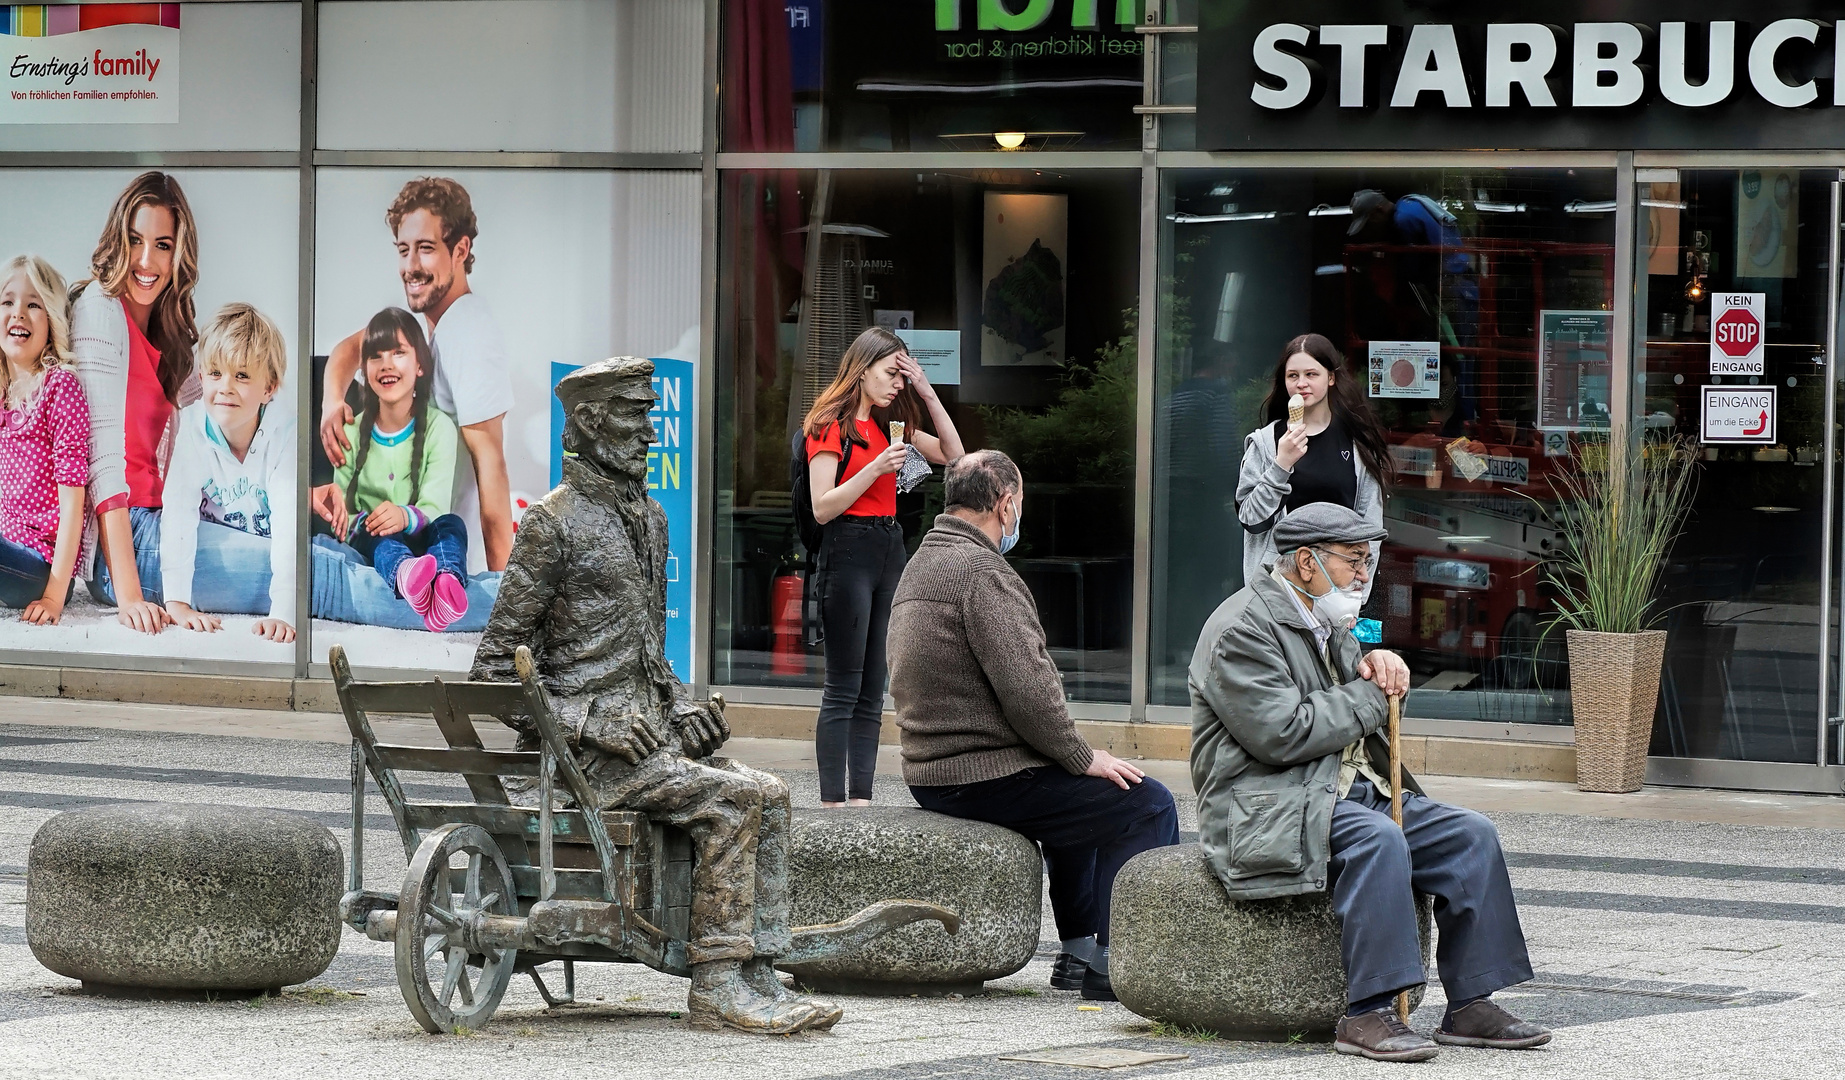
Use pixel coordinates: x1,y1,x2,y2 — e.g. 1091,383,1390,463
321,177,513,572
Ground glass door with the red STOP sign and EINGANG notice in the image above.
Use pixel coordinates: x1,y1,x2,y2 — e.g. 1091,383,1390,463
1635,168,1838,762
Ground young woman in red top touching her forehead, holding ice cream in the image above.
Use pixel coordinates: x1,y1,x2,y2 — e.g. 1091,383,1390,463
803,327,963,807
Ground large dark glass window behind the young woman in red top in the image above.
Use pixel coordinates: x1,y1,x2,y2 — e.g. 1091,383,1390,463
712,170,1140,702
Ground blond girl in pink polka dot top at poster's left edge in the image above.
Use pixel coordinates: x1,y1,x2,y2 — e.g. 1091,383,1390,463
0,255,90,626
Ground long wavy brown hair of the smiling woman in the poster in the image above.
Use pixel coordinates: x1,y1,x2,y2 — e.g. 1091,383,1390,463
70,172,199,404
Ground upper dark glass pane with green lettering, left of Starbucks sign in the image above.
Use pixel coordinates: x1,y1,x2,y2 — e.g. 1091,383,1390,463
723,0,1144,151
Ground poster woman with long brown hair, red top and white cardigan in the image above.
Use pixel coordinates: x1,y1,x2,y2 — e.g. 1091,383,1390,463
70,172,199,633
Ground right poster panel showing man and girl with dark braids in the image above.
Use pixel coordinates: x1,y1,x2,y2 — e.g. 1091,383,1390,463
308,170,696,670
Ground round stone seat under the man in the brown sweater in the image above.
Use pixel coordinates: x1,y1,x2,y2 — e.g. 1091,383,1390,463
786,807,1044,995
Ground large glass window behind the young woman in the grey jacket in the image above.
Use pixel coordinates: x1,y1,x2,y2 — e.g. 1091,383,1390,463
1149,168,1614,724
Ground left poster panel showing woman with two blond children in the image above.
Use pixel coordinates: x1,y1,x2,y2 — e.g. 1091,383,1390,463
0,164,306,663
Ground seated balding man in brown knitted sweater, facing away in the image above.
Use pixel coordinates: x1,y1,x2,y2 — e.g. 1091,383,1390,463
887,450,1179,1001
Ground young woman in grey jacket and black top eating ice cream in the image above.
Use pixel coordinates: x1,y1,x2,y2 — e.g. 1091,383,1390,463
1236,334,1397,598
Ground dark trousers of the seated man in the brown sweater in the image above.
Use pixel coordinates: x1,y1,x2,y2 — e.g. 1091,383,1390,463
910,764,1179,945
